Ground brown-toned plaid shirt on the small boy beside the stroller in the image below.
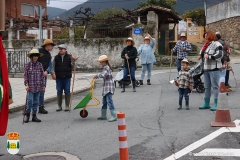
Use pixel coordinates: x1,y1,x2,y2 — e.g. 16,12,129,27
177,70,193,89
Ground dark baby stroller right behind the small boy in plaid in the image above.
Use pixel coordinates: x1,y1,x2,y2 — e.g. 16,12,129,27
189,62,205,93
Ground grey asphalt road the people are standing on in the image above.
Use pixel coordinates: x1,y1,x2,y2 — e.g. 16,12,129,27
0,64,240,160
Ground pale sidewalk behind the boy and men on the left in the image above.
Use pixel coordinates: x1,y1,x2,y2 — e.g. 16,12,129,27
9,75,91,112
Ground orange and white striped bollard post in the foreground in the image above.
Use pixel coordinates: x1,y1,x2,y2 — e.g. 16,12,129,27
117,112,129,160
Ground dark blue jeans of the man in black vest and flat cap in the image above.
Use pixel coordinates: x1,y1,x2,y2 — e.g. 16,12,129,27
56,78,71,94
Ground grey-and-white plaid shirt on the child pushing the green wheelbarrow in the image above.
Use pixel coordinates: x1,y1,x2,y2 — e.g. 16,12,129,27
96,65,115,96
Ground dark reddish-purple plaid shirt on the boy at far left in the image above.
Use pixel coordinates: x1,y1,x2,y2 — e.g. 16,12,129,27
24,62,46,93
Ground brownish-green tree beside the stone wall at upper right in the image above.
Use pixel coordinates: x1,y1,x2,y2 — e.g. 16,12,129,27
182,8,205,26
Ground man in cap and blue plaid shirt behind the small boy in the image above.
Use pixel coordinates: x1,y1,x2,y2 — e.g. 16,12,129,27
171,33,192,72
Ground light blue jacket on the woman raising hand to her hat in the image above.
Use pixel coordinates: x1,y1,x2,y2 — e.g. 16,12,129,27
138,38,156,64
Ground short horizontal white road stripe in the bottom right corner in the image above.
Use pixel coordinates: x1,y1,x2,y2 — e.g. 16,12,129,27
193,148,240,157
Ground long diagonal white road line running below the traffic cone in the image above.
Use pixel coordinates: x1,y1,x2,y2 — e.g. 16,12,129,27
164,120,240,160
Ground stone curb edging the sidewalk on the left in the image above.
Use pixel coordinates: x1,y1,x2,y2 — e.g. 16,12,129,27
8,87,90,113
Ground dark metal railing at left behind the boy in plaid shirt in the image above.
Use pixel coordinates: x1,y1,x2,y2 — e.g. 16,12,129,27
5,48,31,73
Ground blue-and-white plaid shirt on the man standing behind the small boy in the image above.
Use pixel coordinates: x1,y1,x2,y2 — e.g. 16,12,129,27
173,41,192,59
